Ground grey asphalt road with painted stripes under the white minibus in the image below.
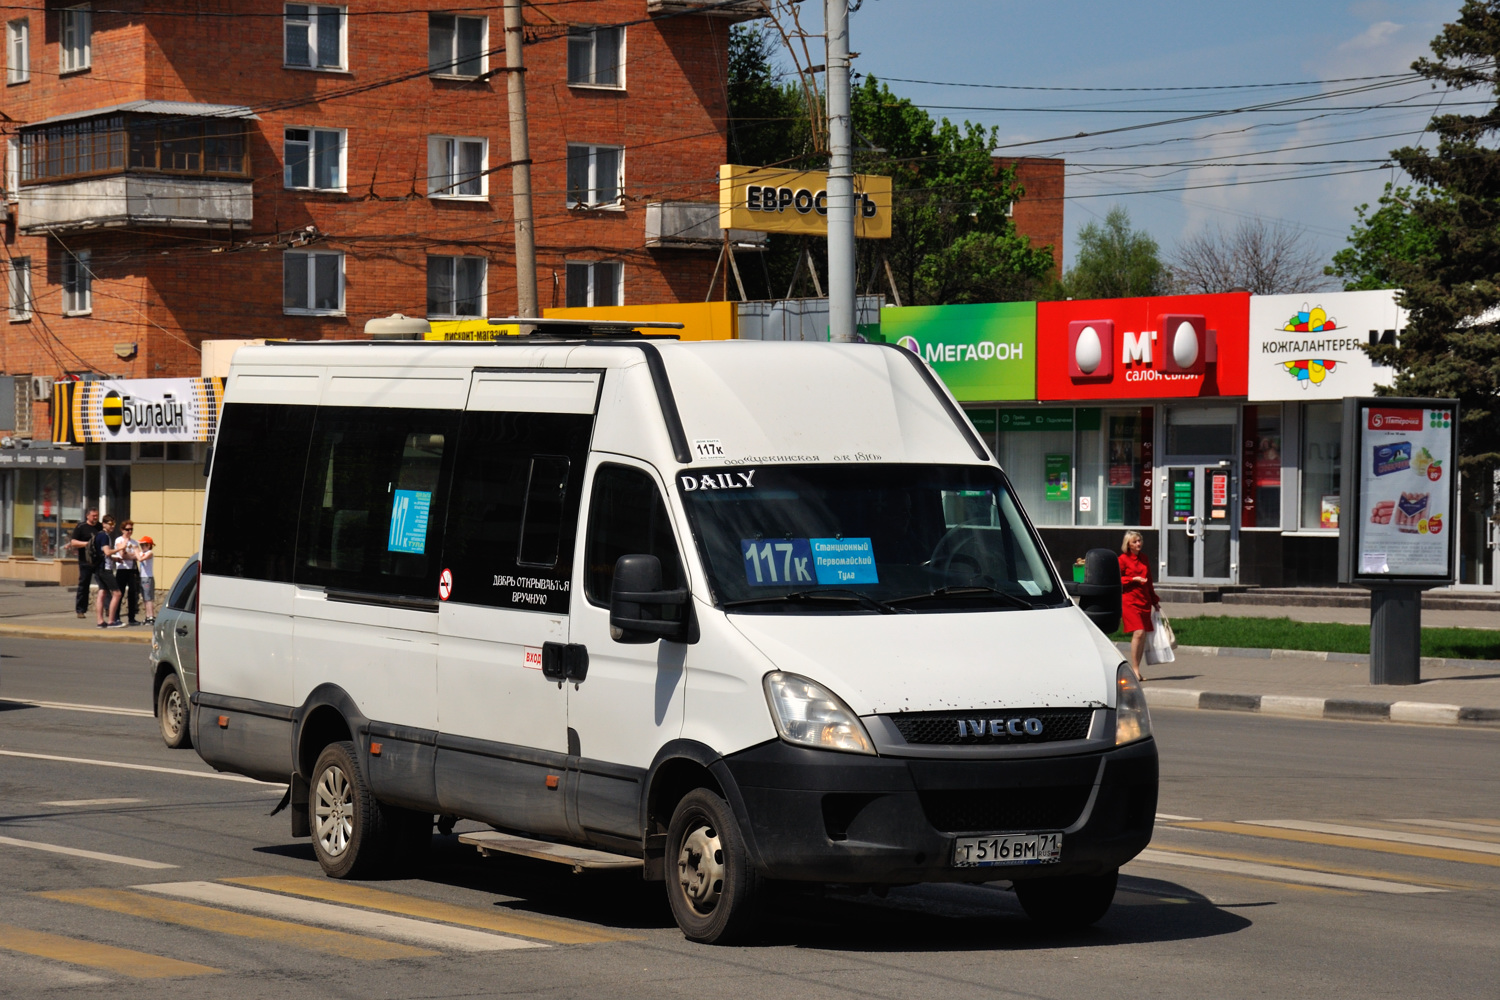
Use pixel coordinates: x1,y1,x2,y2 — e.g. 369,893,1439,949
0,640,1500,1000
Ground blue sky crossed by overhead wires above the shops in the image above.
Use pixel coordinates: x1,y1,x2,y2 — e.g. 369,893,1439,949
803,0,1458,274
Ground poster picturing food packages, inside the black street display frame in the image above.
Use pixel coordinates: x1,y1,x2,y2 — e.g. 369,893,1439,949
1356,400,1457,577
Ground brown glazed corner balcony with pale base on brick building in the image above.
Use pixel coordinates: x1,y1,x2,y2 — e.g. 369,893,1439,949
18,100,255,232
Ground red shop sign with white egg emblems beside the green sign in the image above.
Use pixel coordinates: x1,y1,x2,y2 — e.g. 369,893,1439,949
1037,292,1250,399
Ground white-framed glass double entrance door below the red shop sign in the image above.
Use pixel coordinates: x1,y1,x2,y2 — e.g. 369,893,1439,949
1158,465,1239,583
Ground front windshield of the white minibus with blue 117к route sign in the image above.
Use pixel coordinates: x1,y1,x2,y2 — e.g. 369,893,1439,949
677,463,1068,615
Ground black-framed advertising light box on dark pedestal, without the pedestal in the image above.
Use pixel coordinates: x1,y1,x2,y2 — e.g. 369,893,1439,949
1340,396,1458,586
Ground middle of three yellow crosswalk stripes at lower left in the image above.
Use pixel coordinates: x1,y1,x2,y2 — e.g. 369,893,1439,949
38,889,438,960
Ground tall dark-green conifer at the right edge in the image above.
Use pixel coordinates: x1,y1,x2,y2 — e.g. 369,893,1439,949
1370,0,1500,491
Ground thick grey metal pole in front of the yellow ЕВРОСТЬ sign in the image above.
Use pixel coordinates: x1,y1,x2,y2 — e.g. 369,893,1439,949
824,0,855,343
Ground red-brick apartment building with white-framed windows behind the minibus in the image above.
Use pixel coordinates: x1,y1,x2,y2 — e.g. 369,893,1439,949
0,0,746,419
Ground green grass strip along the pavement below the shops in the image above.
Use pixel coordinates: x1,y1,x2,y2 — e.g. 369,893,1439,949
1115,618,1500,660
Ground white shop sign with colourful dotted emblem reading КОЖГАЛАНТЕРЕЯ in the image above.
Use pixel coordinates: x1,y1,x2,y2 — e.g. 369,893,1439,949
1250,289,1406,402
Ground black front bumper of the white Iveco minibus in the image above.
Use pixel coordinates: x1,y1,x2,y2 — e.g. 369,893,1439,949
714,738,1158,883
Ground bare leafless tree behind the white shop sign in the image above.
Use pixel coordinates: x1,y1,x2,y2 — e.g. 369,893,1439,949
1172,217,1328,295
